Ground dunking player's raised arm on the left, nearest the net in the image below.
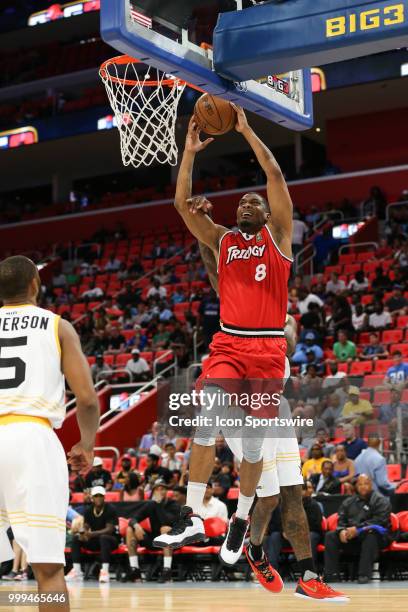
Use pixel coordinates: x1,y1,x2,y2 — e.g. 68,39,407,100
174,117,227,252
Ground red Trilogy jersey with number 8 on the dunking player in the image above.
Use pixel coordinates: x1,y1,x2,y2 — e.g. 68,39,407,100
218,225,292,336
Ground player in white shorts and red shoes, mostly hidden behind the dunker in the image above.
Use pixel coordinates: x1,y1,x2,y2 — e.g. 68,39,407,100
196,213,348,602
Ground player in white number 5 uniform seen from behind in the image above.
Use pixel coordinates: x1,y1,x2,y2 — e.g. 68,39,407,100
0,256,99,612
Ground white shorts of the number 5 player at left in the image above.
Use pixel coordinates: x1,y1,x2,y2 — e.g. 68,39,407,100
0,422,69,565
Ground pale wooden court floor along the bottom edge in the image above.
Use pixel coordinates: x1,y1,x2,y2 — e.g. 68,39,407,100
0,582,408,612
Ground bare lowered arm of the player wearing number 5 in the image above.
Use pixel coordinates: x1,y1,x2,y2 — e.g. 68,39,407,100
59,319,99,471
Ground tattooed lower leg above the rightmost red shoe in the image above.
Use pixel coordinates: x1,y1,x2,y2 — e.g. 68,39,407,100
281,485,312,561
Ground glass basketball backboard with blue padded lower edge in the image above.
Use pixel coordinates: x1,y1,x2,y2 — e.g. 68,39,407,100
101,0,313,130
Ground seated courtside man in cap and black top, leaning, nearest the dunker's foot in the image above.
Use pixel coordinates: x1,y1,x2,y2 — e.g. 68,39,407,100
126,478,180,582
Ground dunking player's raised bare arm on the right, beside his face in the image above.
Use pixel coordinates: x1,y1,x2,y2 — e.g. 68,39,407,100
231,103,293,257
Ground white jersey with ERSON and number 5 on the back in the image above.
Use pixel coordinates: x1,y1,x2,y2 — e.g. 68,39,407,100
0,304,65,429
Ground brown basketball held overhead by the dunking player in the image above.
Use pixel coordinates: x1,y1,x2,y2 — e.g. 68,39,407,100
194,94,237,136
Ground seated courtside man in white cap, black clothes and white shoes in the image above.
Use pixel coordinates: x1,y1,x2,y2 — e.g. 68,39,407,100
66,486,119,582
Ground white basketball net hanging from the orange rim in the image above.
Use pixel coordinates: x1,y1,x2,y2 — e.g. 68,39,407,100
99,58,186,168
